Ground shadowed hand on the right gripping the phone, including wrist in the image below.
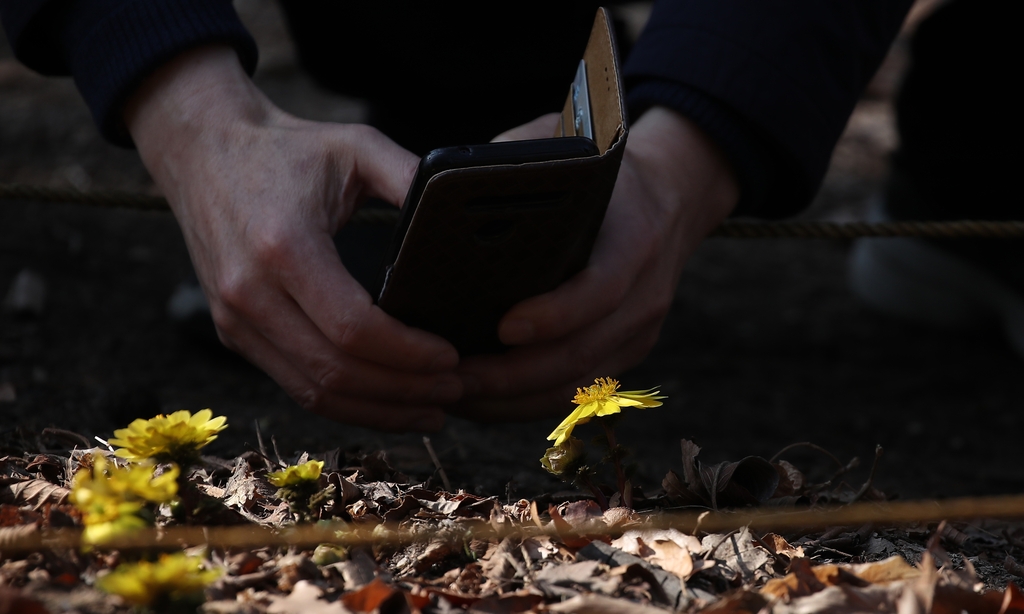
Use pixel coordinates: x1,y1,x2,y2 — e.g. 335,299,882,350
450,107,739,422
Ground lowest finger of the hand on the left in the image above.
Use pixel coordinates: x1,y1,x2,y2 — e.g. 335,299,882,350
211,309,444,432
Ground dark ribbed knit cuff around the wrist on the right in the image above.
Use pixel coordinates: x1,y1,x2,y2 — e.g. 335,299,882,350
627,79,773,215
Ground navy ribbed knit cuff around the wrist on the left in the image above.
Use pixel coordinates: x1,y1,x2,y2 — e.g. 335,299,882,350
68,0,257,146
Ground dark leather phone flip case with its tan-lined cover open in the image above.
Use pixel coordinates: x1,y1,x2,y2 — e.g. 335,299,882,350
378,8,627,355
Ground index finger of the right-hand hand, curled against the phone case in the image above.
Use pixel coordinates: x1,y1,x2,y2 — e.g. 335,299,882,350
498,193,657,345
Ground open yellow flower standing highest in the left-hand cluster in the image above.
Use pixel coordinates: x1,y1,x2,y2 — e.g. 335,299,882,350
111,409,227,467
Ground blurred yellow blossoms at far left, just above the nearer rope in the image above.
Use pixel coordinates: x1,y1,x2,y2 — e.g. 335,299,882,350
69,454,179,543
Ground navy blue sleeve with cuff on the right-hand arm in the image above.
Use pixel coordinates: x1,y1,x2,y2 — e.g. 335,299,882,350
624,0,912,218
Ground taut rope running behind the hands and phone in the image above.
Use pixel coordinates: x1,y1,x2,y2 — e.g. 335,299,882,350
0,183,1024,239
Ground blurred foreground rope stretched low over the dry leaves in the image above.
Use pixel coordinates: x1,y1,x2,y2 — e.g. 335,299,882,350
6,495,1024,556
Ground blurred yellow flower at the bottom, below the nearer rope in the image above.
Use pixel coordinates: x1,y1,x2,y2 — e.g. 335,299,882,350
96,553,220,607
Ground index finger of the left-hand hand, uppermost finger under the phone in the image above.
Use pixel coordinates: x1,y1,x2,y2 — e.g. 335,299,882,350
279,233,459,372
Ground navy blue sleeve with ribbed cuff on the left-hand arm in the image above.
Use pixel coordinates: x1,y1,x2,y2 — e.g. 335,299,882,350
0,0,257,146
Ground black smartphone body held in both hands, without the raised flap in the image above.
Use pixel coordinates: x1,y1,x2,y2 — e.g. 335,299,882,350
375,136,604,354
